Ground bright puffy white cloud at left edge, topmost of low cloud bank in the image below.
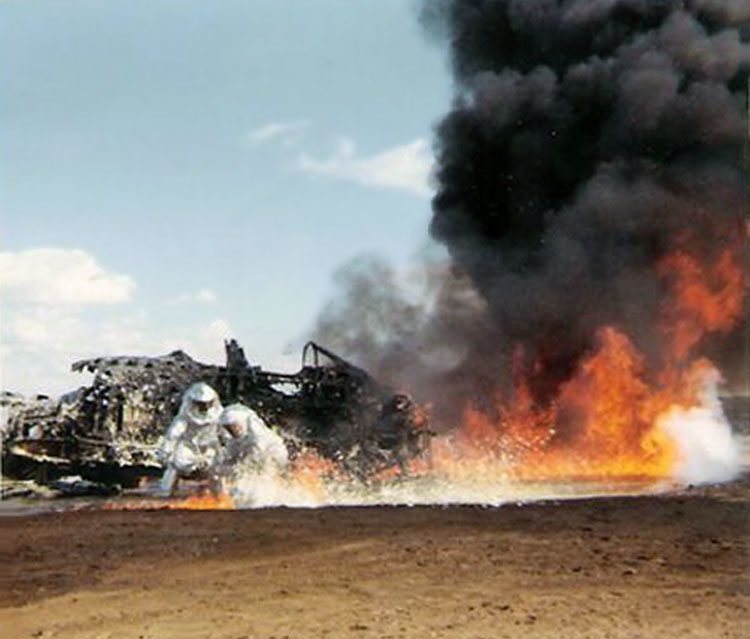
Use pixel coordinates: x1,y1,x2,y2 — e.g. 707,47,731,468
0,248,135,306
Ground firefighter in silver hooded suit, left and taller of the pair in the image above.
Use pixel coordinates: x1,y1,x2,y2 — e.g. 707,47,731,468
160,382,222,497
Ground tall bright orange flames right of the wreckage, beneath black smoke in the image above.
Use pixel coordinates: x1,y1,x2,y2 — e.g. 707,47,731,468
446,240,744,480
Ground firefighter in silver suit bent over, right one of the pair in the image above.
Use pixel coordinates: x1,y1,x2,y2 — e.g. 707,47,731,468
219,404,289,476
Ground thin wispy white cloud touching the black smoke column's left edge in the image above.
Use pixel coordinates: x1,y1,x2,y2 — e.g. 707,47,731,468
297,138,434,198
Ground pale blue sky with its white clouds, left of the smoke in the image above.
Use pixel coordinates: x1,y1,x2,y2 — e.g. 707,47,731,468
0,0,451,393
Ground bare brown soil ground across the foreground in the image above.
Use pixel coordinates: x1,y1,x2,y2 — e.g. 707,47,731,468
0,479,750,639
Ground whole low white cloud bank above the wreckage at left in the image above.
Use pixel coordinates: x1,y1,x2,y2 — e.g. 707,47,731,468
0,248,232,395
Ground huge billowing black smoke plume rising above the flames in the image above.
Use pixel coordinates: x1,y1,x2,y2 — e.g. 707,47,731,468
319,0,750,430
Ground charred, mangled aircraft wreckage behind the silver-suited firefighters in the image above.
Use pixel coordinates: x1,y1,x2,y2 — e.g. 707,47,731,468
2,340,433,487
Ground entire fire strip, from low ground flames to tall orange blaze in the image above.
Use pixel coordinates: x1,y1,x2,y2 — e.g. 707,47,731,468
101,240,745,510
